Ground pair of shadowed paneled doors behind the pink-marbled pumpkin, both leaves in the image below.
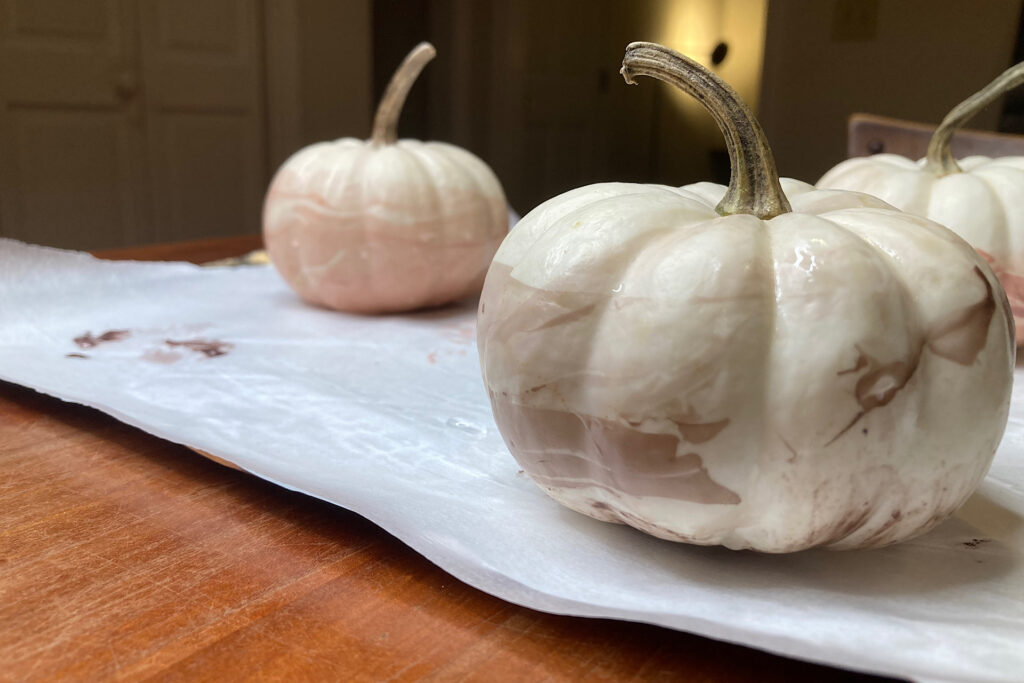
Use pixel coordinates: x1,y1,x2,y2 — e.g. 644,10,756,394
0,0,266,249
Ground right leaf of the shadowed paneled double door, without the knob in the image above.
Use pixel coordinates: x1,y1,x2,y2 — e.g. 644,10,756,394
141,0,266,240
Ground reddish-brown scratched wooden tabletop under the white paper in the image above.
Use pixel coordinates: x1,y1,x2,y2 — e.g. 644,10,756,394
0,237,897,681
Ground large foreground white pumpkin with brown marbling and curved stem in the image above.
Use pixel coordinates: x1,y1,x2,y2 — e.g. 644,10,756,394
478,43,1014,552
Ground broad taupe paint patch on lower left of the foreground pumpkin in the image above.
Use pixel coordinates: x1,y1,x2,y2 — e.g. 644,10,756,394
492,392,740,505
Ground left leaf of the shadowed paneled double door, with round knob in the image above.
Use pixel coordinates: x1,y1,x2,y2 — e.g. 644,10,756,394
0,0,147,249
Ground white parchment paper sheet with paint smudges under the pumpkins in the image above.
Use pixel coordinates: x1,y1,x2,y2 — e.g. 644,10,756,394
0,240,1024,681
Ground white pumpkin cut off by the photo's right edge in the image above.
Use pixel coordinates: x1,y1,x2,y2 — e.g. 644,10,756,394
817,63,1024,344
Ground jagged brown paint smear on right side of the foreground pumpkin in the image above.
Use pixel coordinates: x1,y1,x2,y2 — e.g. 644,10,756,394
825,266,995,445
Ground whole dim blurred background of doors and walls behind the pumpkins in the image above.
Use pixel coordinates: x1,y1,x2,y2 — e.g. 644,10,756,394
0,0,1024,249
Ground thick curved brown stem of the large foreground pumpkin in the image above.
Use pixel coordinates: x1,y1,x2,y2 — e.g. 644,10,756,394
620,43,793,219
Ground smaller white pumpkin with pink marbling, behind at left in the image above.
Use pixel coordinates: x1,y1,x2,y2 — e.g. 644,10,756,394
263,43,508,312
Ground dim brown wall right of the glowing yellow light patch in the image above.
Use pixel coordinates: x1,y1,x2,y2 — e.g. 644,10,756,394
761,0,1024,182
